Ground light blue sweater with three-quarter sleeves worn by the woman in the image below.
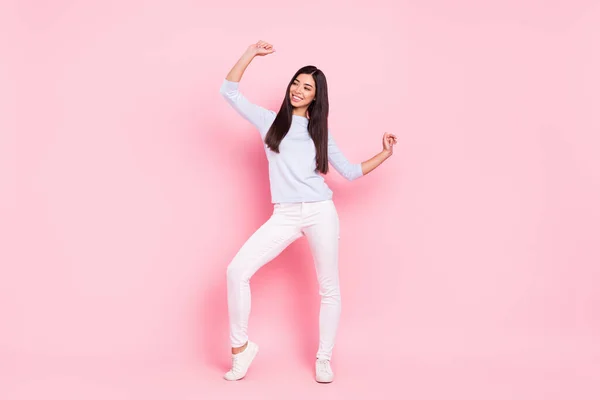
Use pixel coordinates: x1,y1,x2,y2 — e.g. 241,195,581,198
220,79,363,203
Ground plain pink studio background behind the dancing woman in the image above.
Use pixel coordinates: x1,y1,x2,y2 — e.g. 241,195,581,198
0,0,600,400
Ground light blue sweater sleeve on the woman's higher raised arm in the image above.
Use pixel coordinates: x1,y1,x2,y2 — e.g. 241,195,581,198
220,79,277,139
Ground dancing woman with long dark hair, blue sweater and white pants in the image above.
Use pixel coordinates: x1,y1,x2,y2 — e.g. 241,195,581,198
220,41,396,383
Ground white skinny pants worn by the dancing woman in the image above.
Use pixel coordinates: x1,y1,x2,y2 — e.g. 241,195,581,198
227,200,341,360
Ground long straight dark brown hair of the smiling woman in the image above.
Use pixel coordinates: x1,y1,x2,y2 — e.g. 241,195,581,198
265,65,329,174
